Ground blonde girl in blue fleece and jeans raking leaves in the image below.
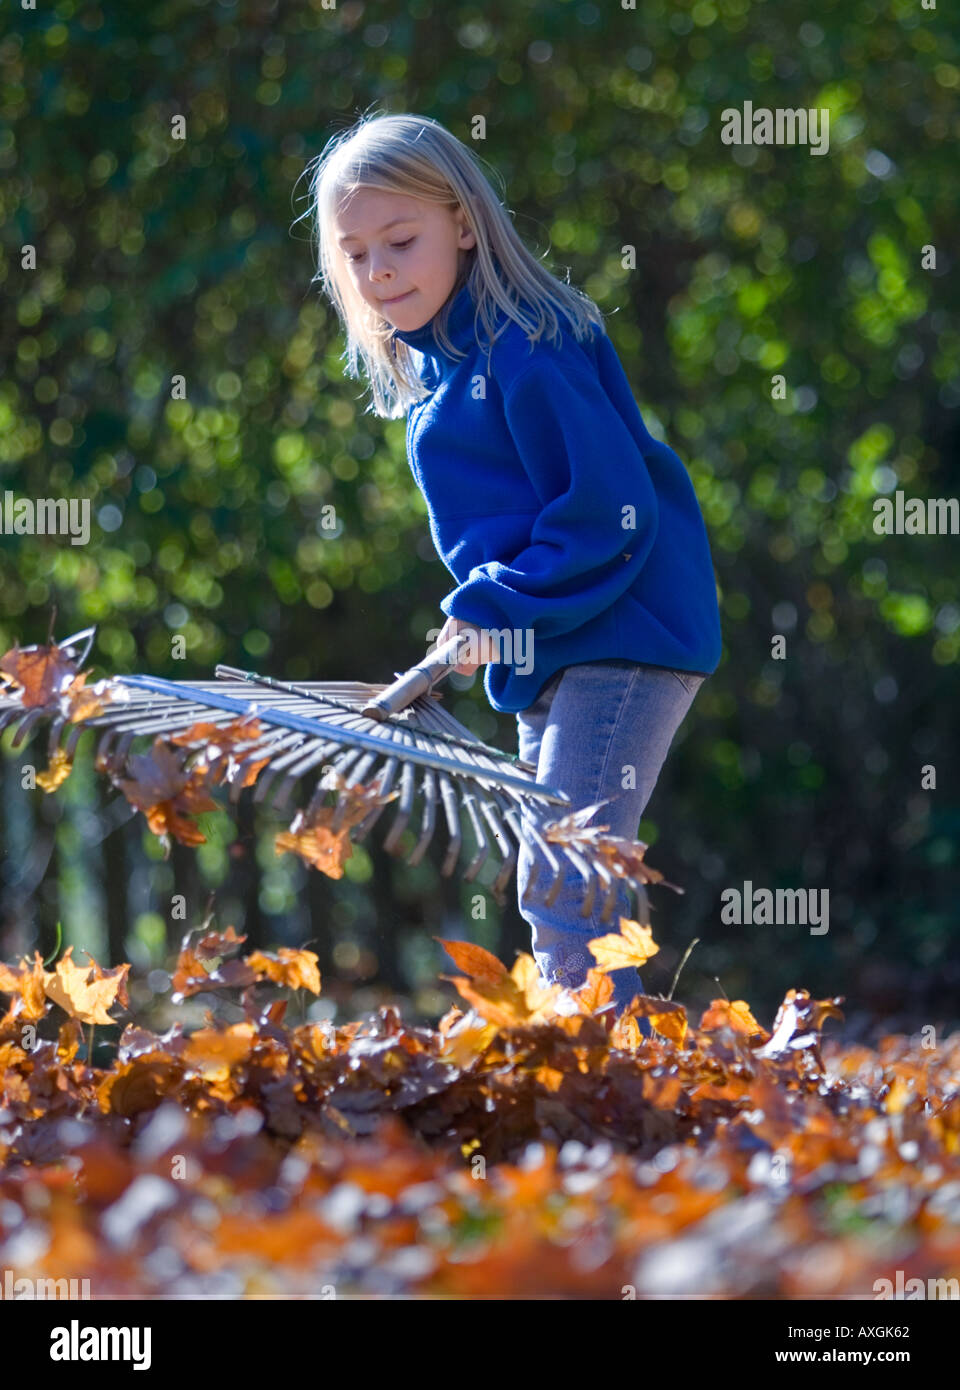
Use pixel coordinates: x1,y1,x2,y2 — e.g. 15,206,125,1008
302,115,721,1011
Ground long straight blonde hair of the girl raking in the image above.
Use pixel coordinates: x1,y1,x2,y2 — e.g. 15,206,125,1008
294,114,606,420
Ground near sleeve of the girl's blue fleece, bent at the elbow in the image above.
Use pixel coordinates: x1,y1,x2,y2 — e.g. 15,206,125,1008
440,354,660,641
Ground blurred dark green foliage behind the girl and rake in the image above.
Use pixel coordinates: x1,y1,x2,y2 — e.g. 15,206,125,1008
0,0,960,1020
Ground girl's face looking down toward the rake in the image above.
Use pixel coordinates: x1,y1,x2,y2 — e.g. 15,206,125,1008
333,188,477,331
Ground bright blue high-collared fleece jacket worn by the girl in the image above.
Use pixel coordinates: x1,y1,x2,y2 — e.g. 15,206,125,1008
393,285,721,713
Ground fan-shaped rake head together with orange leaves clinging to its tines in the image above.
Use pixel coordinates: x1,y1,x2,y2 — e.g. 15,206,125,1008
0,628,679,922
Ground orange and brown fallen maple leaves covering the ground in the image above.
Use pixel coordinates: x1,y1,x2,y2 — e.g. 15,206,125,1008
0,919,960,1298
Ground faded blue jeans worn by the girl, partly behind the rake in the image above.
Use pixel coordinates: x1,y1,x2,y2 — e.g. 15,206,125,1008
517,657,706,1033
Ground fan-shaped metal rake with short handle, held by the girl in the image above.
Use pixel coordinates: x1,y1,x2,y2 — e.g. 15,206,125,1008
0,627,672,922
